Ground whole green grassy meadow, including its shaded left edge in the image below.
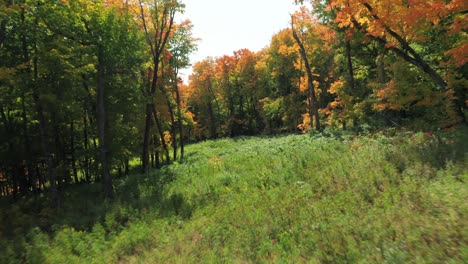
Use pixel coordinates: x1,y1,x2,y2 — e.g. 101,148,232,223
0,128,468,263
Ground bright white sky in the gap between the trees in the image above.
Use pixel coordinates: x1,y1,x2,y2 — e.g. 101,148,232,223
180,0,297,81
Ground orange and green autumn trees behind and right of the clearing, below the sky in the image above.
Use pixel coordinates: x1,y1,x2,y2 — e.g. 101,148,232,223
186,0,468,139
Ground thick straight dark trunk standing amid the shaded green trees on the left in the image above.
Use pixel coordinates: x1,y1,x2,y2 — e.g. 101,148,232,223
96,46,114,198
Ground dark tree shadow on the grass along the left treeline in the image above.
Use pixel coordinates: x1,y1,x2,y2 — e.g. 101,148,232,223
0,163,194,262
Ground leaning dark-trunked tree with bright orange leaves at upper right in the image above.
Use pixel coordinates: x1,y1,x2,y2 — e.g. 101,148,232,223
328,0,465,91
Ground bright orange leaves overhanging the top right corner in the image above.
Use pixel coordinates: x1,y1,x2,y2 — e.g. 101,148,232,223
327,0,468,66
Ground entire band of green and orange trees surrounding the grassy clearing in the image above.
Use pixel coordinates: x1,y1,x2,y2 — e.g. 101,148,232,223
0,0,468,206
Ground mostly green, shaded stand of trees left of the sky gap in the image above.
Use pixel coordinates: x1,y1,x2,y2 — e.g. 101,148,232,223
0,0,196,202
